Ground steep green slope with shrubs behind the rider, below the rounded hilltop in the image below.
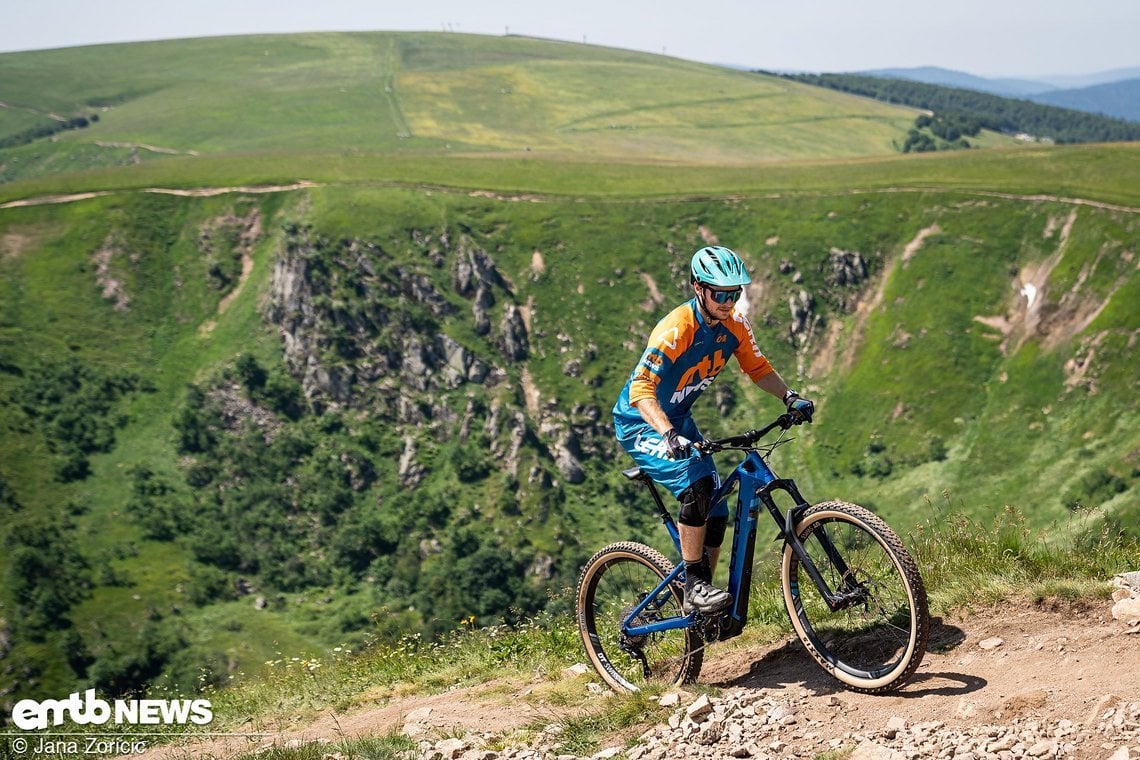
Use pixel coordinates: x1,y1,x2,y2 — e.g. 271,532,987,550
0,170,1138,706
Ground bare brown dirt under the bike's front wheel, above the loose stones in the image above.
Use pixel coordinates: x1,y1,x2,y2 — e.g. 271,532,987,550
702,600,1140,733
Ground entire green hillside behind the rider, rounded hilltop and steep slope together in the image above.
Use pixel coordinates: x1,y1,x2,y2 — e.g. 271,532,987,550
0,34,1140,715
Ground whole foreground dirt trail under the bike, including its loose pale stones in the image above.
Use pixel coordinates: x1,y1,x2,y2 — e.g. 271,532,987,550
142,575,1140,760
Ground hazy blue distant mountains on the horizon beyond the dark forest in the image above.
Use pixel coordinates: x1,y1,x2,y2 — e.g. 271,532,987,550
858,66,1140,122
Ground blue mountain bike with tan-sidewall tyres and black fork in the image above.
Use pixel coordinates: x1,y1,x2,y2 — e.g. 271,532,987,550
577,414,930,694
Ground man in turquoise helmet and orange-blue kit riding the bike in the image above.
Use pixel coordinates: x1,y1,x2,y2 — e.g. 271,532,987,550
613,246,815,614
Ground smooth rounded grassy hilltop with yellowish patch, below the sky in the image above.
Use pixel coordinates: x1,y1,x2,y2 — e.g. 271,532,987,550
0,33,1003,181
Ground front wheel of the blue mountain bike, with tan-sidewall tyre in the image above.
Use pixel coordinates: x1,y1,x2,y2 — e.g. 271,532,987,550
781,501,930,694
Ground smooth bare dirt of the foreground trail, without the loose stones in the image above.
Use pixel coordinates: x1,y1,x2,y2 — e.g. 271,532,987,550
135,600,1140,760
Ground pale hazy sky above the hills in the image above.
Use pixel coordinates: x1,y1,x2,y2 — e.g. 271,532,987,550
0,0,1140,78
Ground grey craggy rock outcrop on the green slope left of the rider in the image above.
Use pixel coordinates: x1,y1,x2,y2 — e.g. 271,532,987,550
267,227,609,487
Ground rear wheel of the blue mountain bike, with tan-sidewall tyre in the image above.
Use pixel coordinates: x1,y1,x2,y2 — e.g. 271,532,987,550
578,541,705,692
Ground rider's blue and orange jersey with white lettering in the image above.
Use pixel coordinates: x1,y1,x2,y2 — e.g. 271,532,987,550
613,299,772,439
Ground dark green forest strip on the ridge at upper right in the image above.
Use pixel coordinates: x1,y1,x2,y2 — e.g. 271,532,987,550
759,72,1140,144
